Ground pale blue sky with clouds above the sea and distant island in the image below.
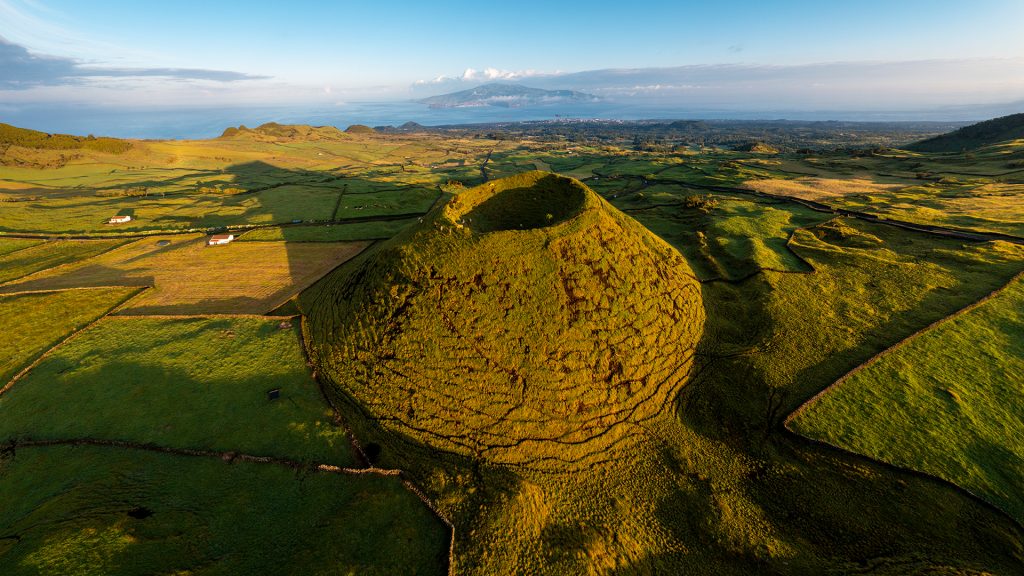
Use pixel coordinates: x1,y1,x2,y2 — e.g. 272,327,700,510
0,0,1024,115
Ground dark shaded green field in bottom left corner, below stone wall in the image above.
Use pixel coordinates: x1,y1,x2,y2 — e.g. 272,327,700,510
0,447,447,576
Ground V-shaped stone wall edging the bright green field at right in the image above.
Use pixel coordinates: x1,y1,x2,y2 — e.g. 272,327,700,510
781,271,1024,531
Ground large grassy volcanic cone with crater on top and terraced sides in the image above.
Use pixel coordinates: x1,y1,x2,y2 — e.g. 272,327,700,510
303,171,705,469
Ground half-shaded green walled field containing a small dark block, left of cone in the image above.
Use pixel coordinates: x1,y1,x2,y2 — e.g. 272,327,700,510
0,318,350,465
